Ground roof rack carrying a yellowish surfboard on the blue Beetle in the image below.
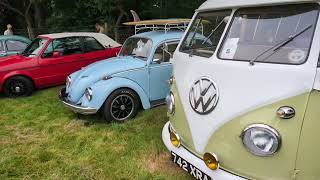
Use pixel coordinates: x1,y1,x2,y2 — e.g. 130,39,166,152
123,19,191,34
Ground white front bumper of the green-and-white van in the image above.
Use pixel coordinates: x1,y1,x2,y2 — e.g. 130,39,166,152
162,122,244,180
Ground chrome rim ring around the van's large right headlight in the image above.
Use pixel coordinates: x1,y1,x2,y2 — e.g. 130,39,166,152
241,124,282,157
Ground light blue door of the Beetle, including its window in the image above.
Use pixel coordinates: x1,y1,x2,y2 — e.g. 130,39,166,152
149,41,179,104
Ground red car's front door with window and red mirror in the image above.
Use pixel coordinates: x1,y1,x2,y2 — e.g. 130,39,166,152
39,37,84,85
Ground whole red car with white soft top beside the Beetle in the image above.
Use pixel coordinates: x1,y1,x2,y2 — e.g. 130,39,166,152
0,33,121,97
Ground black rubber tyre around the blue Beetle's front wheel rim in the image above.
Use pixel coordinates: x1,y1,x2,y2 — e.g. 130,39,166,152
102,89,139,123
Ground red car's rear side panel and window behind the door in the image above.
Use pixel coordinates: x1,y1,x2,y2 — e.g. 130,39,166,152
83,37,114,66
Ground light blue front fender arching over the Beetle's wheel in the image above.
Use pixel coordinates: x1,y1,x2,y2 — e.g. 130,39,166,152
81,77,151,109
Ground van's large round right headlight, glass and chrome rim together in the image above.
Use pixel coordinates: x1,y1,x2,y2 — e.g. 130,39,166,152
241,124,281,156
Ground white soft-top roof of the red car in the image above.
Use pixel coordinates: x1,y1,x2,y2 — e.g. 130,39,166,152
40,32,121,47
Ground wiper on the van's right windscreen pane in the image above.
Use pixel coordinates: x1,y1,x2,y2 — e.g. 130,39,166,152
250,24,313,65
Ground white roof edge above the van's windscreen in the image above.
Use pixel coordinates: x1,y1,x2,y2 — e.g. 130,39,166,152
198,0,320,11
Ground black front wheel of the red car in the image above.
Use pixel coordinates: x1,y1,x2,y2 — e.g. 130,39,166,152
3,76,34,98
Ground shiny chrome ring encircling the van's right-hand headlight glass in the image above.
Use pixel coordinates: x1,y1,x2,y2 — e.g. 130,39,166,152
240,124,281,157
